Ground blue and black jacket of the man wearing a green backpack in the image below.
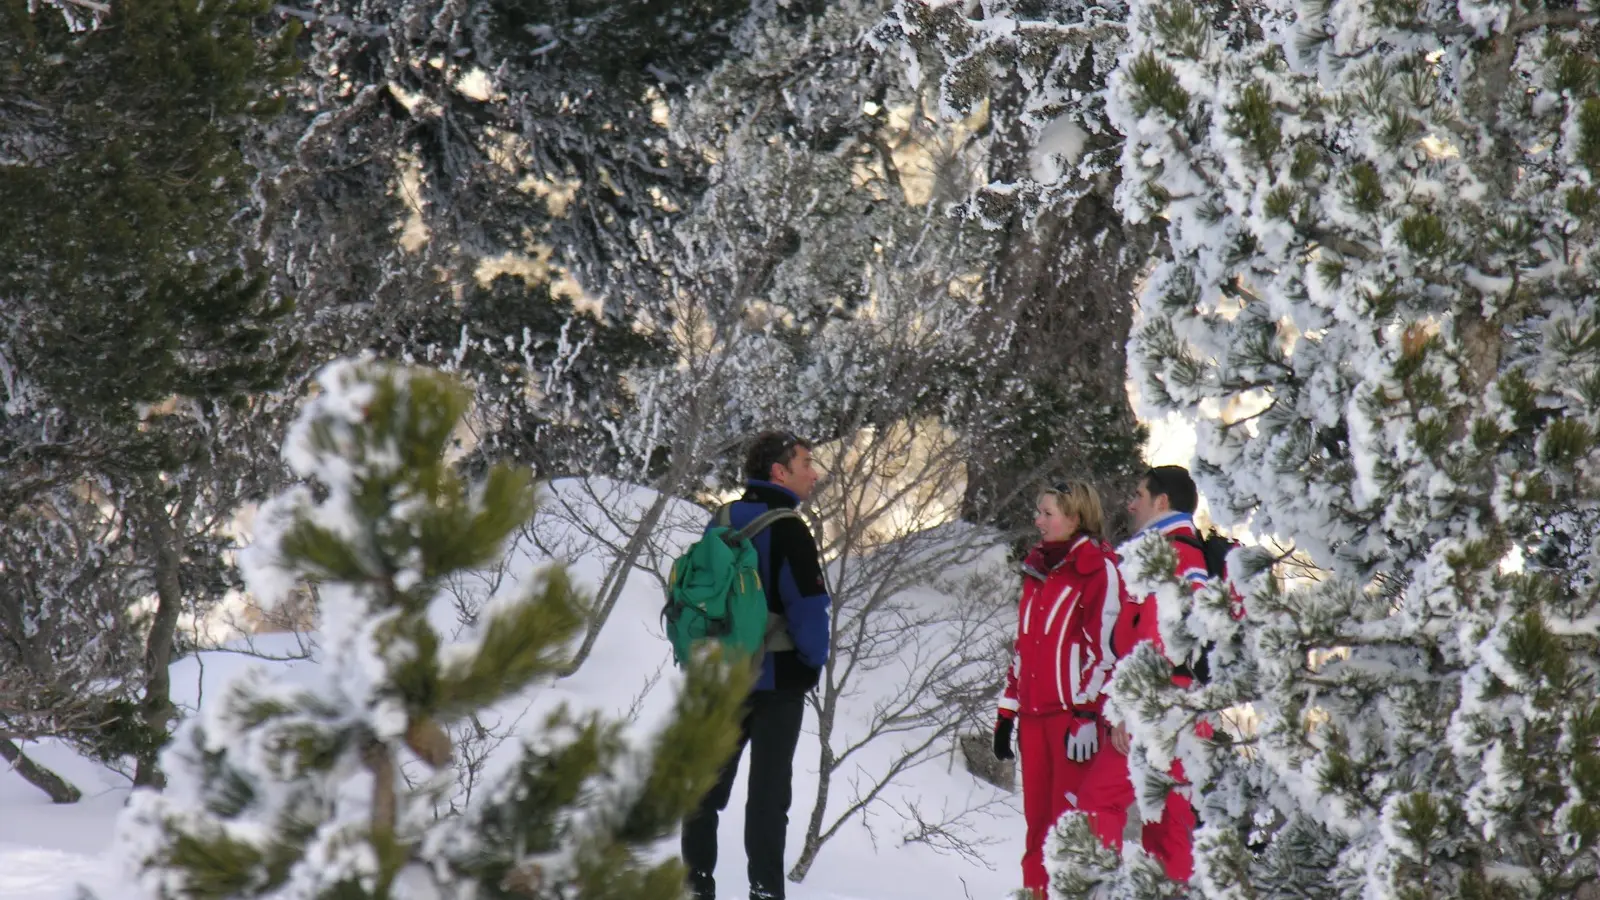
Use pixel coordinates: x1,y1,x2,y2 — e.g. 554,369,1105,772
707,480,834,690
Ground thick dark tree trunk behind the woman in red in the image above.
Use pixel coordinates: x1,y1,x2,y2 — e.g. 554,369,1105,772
963,68,1150,536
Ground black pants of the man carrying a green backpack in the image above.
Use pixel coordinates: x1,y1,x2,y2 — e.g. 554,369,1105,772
683,690,805,900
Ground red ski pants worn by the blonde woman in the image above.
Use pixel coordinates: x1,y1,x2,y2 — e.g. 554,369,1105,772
1016,713,1094,897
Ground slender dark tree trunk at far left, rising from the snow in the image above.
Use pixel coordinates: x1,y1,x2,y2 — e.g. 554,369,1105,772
133,485,184,788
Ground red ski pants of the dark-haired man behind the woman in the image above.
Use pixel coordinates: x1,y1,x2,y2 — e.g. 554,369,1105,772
1078,723,1195,882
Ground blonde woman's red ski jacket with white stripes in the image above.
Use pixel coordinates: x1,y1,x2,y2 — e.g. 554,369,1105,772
1000,535,1126,716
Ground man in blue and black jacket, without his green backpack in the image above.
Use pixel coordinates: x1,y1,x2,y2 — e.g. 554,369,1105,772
683,431,832,900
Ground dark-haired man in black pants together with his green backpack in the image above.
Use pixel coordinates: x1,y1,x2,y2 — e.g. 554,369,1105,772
666,431,832,900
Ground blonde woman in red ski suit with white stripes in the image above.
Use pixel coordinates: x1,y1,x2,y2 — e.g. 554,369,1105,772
994,484,1125,898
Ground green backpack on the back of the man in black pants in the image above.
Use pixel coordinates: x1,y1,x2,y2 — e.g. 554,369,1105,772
661,506,800,666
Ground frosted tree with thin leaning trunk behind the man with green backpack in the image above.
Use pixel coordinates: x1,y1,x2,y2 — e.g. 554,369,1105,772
537,0,1010,672
